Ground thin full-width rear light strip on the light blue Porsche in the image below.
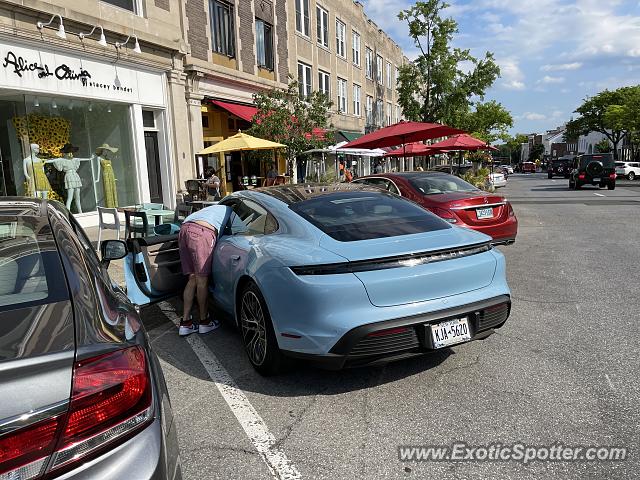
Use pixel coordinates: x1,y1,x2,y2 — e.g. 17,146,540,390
290,243,492,275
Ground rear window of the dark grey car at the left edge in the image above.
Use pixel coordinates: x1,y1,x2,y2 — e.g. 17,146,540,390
0,216,69,311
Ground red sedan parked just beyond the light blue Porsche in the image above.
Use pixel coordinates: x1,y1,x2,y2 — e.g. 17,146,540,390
354,172,518,244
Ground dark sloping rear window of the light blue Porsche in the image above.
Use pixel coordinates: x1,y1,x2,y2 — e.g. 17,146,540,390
289,191,451,242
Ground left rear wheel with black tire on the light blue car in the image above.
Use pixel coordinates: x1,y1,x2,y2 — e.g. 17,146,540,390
238,282,284,376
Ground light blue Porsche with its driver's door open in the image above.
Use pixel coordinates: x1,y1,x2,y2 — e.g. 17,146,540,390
126,184,511,374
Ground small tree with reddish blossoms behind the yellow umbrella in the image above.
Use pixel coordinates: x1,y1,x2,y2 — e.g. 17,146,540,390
248,80,333,177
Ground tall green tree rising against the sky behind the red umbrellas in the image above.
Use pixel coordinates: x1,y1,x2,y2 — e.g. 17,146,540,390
398,0,500,125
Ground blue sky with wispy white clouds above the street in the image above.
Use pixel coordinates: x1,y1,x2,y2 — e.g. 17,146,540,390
362,0,640,133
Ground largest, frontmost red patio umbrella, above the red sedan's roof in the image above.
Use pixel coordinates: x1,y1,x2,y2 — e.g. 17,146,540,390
344,121,464,148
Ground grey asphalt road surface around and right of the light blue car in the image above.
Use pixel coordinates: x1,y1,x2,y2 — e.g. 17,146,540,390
144,174,640,479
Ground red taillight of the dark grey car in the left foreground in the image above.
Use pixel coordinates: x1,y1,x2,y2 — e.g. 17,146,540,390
0,346,153,480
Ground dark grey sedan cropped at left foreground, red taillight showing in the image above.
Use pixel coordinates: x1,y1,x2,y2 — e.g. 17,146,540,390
0,197,181,479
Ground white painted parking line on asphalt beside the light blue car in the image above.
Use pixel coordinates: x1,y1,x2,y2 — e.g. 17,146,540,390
158,302,302,480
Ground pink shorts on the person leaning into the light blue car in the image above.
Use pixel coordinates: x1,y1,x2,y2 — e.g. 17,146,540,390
178,222,216,276
